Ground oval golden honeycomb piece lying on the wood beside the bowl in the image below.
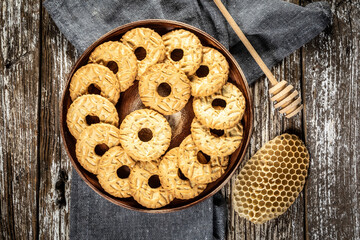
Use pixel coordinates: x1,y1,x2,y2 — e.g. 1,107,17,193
233,134,309,223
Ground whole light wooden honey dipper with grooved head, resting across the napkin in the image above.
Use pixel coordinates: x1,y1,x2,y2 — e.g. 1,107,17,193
214,0,303,118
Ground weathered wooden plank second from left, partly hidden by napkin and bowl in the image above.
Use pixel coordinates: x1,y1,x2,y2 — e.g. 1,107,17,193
39,9,77,239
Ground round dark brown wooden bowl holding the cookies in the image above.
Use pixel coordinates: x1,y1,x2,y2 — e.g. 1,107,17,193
60,19,253,213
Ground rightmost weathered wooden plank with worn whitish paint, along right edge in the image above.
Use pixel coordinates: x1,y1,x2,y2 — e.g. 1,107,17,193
303,0,360,239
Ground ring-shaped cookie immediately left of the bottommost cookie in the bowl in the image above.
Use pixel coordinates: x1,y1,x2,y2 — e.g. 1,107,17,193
97,146,135,198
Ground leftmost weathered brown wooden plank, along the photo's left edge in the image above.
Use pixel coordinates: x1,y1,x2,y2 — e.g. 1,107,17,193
0,0,40,239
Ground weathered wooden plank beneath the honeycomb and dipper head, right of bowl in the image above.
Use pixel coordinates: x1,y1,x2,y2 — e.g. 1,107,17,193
225,44,304,239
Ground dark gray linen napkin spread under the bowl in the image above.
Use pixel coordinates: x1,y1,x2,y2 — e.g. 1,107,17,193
44,0,331,240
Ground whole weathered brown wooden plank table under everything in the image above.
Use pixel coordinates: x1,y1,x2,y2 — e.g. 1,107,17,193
0,0,360,239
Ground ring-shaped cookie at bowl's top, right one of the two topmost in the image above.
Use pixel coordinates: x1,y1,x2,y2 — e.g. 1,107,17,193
162,29,202,76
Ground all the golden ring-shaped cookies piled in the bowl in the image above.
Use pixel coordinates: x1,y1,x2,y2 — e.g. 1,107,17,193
67,28,246,208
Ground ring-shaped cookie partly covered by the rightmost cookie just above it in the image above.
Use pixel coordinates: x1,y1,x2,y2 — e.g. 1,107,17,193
191,117,243,157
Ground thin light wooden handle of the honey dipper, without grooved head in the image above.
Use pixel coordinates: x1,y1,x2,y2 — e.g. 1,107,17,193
214,0,278,86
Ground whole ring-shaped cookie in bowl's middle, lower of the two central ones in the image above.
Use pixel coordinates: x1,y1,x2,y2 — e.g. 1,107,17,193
120,109,171,161
